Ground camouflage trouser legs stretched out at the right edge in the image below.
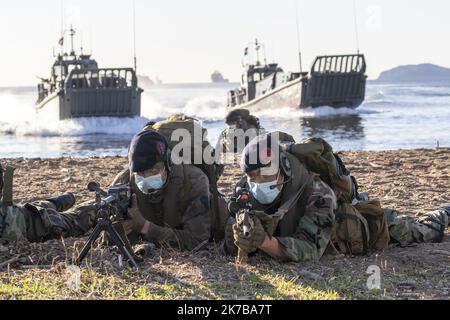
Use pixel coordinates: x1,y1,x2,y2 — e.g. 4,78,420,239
385,205,450,245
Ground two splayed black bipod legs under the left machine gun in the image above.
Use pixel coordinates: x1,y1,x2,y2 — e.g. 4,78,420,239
76,217,138,268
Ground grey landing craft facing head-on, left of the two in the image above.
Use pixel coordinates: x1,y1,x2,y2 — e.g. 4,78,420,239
36,27,143,120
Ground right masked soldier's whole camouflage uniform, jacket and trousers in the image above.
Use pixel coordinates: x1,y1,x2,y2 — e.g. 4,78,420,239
226,153,450,262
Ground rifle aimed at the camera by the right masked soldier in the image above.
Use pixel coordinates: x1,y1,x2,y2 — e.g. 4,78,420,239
228,188,255,263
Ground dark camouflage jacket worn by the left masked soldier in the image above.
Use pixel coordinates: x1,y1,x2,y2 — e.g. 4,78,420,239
113,165,212,250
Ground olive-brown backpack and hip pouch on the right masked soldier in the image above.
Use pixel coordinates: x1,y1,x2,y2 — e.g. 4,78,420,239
280,138,390,255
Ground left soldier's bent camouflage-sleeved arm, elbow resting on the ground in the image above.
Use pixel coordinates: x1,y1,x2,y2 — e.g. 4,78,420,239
143,172,212,250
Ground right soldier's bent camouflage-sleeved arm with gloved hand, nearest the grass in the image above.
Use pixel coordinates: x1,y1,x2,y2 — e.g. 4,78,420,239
266,178,337,262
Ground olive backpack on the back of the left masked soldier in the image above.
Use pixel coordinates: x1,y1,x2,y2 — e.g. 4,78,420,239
144,113,228,241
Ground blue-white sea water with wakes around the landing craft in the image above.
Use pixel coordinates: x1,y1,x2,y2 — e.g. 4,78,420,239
0,82,450,158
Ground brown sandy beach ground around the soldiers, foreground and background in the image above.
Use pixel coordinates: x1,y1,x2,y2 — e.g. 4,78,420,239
0,148,450,299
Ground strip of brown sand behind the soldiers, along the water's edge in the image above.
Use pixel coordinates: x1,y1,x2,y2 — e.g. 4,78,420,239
1,148,450,214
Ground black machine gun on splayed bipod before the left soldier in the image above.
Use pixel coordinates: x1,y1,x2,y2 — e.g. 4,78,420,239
76,182,138,268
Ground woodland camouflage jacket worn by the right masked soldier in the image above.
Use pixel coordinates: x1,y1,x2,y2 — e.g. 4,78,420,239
234,154,337,262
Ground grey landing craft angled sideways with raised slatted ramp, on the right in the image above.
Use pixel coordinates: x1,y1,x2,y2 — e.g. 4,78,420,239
228,40,367,110
